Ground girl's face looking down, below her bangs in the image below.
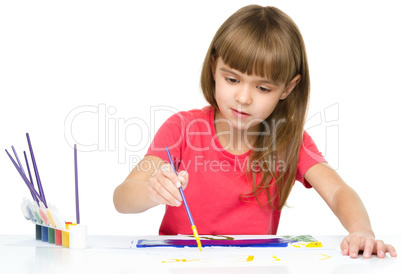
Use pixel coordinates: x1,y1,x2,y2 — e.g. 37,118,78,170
212,57,300,134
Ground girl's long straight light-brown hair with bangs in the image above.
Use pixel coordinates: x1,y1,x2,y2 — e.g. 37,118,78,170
201,5,310,210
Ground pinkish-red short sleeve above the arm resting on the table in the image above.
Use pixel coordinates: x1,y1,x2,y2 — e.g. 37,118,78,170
296,131,326,188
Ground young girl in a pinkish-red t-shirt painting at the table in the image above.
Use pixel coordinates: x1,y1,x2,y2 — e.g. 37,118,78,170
114,5,396,258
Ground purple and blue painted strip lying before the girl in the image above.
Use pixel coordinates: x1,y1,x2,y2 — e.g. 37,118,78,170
137,238,295,248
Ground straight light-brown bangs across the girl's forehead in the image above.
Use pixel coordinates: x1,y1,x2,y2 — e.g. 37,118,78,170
213,8,298,83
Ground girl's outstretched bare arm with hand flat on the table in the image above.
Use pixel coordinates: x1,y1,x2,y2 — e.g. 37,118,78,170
304,163,396,258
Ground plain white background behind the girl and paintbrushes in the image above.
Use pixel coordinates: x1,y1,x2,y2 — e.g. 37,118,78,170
0,0,402,239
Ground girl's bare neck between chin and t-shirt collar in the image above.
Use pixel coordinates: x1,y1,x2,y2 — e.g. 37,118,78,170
214,110,257,155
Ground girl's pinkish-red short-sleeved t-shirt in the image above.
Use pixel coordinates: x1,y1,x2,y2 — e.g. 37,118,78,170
147,107,325,235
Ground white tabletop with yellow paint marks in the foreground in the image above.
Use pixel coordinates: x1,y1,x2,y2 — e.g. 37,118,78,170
0,235,402,274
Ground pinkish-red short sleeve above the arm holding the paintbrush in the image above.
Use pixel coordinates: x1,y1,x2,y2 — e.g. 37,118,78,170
145,112,185,168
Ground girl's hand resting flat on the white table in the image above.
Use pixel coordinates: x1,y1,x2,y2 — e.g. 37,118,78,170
341,232,396,258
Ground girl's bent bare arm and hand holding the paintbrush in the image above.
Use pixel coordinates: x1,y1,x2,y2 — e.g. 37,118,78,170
113,155,188,213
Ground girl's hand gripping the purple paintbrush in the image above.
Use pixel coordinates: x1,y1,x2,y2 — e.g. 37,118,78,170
148,164,188,207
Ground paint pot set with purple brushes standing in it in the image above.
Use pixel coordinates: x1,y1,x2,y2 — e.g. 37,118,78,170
5,133,87,249
